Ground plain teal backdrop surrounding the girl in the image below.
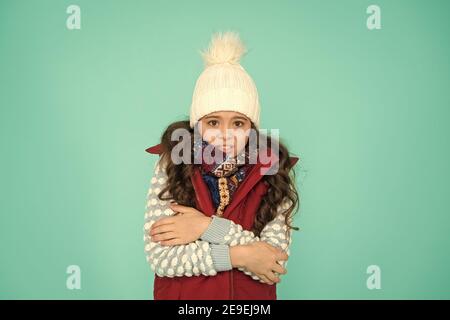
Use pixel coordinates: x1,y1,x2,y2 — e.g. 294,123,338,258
0,0,450,299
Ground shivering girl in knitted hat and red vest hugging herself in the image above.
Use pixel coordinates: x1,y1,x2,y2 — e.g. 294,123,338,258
144,32,298,300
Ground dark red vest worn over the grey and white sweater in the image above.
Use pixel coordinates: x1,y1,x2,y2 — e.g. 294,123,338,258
145,144,298,300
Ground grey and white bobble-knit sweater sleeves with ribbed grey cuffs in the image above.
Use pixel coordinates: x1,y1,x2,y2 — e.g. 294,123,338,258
144,161,292,282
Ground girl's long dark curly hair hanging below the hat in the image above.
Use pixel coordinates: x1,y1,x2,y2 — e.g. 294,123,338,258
158,121,300,236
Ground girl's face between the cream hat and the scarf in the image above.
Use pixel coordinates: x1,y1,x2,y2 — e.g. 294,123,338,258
199,111,252,156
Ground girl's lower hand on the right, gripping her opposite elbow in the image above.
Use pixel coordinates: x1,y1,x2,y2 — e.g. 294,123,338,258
236,241,288,285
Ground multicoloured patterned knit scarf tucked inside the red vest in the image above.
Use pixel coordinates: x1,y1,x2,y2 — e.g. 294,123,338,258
194,139,253,216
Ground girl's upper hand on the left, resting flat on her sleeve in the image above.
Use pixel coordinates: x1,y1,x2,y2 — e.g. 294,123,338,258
150,204,212,246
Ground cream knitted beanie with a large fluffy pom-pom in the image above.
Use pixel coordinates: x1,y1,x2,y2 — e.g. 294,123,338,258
190,31,260,128
